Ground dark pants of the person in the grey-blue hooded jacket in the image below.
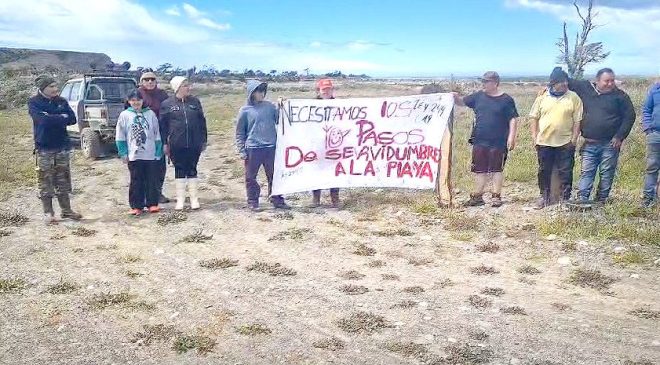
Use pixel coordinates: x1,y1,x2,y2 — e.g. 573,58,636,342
245,147,283,204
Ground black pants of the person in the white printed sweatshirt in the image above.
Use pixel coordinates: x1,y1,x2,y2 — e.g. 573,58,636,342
128,160,159,209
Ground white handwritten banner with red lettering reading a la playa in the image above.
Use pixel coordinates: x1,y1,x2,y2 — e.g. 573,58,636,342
273,94,454,194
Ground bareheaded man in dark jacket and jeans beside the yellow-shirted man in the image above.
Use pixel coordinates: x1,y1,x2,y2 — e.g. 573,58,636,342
568,68,636,203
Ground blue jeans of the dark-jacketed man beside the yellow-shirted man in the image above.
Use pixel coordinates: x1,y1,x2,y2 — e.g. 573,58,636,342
578,141,620,202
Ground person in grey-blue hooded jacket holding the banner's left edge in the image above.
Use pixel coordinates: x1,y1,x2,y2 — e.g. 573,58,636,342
236,80,290,210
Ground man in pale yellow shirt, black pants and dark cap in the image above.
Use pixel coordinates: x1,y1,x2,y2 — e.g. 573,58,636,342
529,68,582,209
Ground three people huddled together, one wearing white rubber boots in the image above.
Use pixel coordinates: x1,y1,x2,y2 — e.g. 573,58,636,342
115,72,207,215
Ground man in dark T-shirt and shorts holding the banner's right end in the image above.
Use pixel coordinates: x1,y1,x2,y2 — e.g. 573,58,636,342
454,71,518,207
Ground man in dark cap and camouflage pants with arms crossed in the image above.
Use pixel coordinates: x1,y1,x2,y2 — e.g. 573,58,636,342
28,75,82,223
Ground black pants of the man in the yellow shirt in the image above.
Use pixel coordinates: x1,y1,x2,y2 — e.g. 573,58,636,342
536,143,575,200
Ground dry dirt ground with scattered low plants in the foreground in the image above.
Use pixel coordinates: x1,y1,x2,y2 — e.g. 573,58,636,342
0,89,660,364
